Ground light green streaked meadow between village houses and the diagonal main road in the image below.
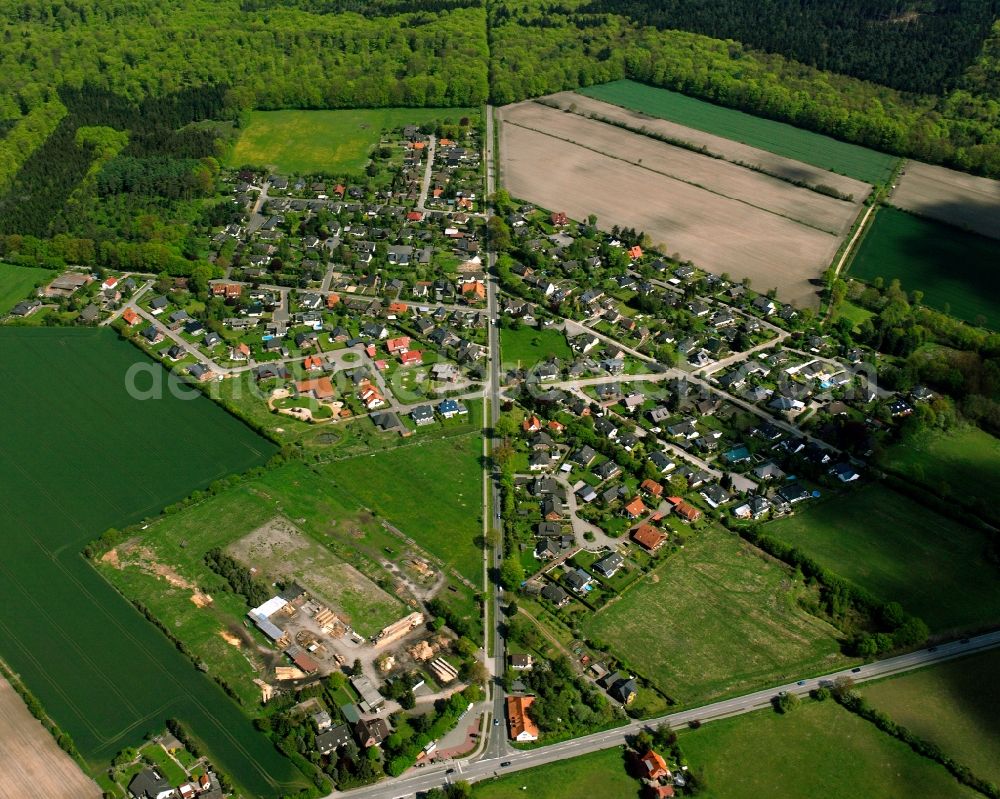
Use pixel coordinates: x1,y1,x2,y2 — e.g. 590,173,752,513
583,527,844,705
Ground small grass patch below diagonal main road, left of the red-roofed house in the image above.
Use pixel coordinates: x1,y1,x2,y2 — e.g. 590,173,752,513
472,746,640,799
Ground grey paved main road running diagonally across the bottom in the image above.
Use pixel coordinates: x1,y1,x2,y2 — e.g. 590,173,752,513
330,631,1000,799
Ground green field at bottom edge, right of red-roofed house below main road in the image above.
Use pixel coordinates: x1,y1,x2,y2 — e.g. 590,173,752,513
680,700,979,799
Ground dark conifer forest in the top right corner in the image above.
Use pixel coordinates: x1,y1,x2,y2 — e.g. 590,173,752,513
583,0,1000,94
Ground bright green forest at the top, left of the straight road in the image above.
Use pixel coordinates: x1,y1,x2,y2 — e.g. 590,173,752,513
0,0,488,113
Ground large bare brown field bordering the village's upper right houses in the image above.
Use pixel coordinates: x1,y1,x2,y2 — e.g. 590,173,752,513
500,106,844,307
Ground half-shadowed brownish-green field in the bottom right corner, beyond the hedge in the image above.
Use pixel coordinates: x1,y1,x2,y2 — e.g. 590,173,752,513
859,650,1000,784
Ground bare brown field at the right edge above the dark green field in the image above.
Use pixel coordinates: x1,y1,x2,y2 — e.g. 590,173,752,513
892,161,1000,239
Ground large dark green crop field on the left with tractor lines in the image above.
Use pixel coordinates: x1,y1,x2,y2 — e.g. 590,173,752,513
0,328,302,797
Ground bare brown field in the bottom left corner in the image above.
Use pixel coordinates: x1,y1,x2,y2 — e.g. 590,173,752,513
0,678,101,799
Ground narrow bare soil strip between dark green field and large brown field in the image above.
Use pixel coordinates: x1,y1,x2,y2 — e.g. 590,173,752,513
545,92,871,203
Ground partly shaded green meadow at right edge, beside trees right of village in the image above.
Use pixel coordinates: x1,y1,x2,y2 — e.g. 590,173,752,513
885,425,1000,518
